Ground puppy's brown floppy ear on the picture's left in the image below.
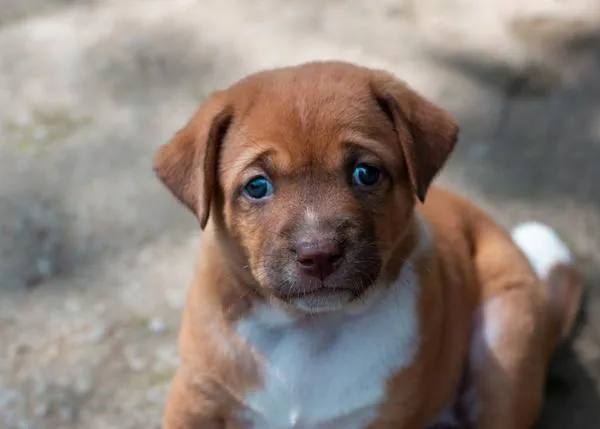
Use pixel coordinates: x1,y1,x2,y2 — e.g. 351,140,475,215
154,93,232,229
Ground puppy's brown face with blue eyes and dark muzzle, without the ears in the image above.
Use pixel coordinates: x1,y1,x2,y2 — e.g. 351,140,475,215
220,95,413,311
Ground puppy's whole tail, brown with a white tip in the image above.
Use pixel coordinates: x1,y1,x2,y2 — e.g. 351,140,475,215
512,222,584,346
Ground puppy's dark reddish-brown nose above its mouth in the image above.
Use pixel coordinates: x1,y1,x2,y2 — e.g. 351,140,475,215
295,240,342,280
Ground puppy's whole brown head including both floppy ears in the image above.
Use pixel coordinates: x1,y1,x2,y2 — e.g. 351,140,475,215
155,62,458,312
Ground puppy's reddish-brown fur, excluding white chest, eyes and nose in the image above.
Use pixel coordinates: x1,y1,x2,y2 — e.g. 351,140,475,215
155,62,579,429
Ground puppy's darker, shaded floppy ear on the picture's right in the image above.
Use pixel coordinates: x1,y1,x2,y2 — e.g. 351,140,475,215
371,72,459,202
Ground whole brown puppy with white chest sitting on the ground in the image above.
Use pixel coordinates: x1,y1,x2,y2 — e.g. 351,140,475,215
155,62,582,429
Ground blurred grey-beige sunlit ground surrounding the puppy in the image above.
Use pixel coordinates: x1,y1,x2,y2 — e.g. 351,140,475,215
0,0,600,429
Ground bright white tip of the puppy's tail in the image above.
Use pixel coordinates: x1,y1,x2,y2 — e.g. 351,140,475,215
512,222,573,279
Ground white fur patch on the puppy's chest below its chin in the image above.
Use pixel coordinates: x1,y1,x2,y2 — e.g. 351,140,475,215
236,254,419,429
